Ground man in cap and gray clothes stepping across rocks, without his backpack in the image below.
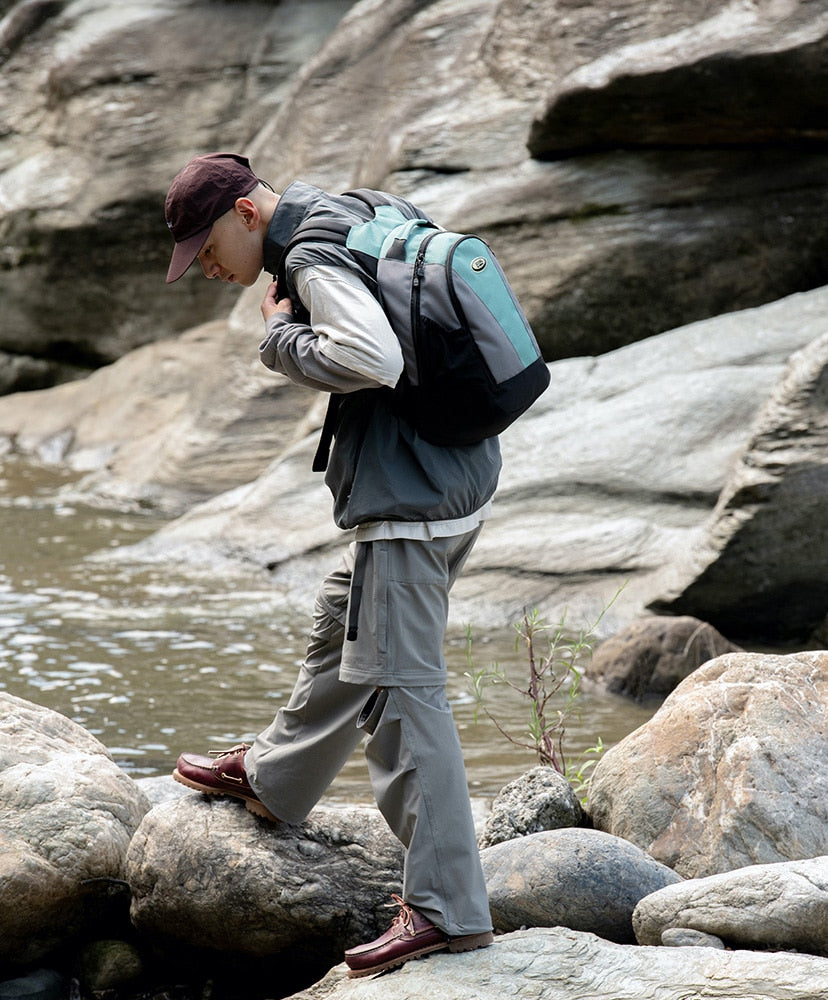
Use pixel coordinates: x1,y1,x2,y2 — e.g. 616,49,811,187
166,153,500,976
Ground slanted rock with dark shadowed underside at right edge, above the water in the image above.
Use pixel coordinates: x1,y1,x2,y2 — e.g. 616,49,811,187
653,332,828,643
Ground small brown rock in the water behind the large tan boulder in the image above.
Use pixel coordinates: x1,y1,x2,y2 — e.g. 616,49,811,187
584,615,739,701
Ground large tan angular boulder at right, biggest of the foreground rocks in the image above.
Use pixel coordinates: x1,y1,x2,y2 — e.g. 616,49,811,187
589,652,828,878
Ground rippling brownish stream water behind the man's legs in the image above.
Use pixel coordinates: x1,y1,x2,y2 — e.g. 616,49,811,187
0,459,652,802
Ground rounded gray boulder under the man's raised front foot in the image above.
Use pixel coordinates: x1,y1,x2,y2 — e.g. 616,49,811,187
126,793,402,969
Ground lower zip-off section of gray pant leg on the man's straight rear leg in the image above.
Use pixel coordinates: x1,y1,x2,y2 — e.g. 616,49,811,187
366,685,492,937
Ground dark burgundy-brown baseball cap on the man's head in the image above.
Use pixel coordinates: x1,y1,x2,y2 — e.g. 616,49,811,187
164,153,259,283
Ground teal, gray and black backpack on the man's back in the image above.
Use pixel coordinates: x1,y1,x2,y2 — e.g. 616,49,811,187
282,188,549,469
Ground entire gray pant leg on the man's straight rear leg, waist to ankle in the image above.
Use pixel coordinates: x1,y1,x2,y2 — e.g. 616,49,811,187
360,531,492,937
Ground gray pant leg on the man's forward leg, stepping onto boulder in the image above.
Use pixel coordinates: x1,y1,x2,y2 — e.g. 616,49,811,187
244,552,374,823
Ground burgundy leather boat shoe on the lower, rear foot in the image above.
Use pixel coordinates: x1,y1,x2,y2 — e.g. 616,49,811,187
345,896,494,979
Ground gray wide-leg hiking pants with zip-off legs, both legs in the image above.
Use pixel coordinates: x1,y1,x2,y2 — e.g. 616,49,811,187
245,528,491,937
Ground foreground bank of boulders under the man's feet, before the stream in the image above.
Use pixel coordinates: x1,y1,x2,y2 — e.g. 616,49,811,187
0,652,828,1000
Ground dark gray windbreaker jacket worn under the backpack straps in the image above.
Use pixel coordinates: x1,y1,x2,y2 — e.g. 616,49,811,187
259,181,501,528
